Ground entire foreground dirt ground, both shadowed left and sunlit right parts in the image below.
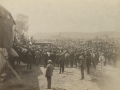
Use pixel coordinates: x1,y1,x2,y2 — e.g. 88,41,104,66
0,62,120,90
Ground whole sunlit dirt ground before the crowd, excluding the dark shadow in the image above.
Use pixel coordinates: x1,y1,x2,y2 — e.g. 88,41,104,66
38,62,120,90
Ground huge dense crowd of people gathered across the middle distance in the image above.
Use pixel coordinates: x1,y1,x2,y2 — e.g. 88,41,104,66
13,39,120,76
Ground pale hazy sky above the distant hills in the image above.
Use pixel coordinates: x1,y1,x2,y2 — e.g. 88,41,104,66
0,0,120,34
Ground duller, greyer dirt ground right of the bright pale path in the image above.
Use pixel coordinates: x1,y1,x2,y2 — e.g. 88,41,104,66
90,62,120,90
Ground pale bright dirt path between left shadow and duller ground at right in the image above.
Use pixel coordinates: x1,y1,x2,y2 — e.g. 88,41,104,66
39,67,100,90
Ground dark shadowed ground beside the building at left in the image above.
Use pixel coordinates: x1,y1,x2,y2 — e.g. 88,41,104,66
0,63,42,90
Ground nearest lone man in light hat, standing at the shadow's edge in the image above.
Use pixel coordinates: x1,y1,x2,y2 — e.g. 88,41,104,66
45,60,54,89
